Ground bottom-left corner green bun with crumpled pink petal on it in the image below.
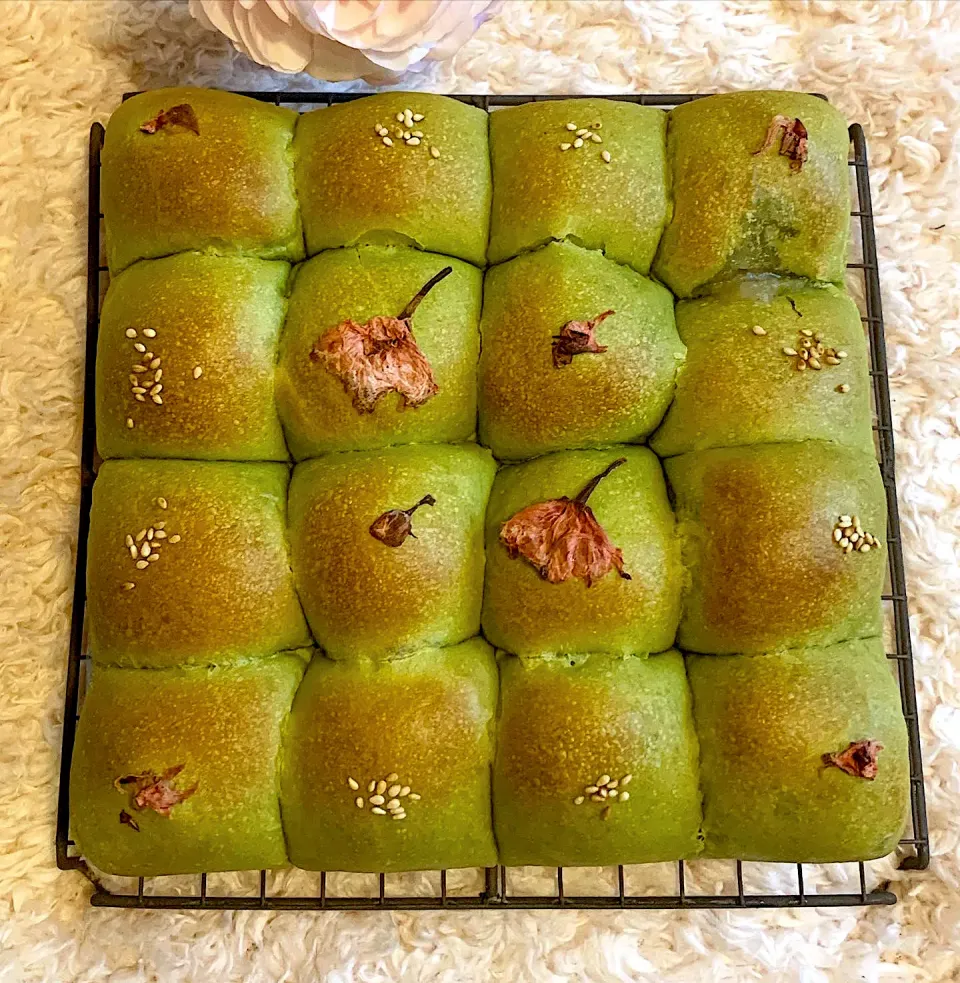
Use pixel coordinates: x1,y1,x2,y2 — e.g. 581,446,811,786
70,652,310,876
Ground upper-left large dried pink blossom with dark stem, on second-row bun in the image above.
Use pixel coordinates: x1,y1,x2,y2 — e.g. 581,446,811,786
310,266,453,413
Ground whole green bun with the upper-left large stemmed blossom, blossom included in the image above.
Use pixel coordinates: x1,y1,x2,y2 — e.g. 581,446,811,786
277,246,482,459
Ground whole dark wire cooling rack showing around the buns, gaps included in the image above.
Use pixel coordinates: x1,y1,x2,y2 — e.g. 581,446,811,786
56,91,930,911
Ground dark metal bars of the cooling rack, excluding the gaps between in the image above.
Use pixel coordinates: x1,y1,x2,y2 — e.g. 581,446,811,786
56,91,930,911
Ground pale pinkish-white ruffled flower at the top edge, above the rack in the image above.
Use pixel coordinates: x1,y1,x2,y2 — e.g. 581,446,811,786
190,0,499,82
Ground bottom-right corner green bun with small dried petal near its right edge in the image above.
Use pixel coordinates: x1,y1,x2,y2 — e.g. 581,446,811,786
687,638,910,863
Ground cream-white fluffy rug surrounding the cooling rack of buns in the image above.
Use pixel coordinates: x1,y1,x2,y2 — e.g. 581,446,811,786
0,0,960,983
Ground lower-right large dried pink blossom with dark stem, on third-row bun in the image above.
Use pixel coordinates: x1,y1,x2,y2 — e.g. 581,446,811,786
500,457,630,587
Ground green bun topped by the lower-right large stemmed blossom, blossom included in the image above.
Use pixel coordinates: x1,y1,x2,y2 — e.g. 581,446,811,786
483,447,681,656
